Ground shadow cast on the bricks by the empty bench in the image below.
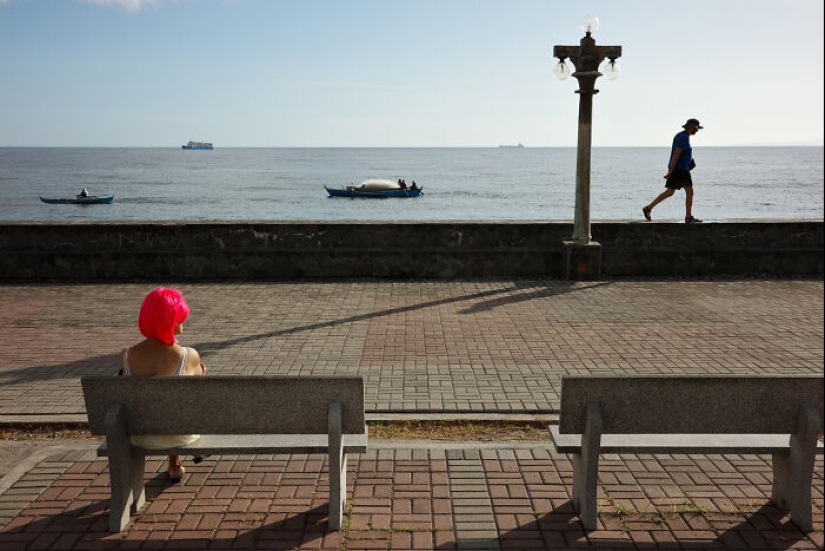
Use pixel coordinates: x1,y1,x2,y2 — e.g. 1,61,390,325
490,502,815,551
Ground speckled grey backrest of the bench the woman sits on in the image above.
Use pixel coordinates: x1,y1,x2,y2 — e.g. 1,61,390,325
80,375,365,434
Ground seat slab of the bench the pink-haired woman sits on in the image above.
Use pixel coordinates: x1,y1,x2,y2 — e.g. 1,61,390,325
97,430,367,457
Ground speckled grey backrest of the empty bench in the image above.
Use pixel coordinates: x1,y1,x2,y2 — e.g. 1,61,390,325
559,375,823,434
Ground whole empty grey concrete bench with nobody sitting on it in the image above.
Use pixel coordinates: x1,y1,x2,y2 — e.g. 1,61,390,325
550,375,823,531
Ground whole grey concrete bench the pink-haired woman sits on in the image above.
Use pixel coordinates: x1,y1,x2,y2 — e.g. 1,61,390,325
81,376,367,532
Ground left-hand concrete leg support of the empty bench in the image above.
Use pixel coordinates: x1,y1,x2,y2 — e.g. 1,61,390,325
572,402,602,530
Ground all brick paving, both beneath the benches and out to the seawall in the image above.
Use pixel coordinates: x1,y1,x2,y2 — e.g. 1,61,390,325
0,280,823,551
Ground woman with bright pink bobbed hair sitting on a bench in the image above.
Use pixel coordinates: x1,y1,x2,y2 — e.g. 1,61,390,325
120,287,206,483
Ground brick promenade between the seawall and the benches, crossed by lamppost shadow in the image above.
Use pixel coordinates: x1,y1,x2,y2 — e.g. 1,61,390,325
0,279,825,420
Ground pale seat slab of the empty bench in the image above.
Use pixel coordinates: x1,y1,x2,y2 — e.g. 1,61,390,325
550,425,825,454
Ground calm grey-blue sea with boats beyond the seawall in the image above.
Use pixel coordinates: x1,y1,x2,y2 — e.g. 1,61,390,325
0,149,825,222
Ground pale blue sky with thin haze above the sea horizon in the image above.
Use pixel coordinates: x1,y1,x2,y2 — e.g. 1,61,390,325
0,0,825,147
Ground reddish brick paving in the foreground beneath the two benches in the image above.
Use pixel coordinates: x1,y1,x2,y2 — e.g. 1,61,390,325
0,443,823,551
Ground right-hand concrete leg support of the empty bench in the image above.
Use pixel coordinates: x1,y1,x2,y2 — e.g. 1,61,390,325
771,404,820,532
